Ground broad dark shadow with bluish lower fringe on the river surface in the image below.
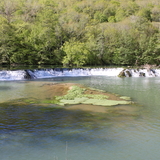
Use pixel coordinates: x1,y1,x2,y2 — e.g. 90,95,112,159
0,103,116,146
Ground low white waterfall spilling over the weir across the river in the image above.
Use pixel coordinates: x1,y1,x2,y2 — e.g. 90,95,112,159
0,68,160,81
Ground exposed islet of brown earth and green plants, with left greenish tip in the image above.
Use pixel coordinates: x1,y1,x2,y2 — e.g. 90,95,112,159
16,83,131,106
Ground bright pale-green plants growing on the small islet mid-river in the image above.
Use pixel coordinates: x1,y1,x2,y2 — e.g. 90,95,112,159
56,85,131,106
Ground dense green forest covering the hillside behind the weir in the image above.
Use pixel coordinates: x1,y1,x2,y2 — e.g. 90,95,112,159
0,0,160,67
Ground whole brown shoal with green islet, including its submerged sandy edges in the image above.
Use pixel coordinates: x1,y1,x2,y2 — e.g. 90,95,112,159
2,82,137,117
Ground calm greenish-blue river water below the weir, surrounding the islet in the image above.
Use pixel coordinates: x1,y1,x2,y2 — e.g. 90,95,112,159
0,76,160,160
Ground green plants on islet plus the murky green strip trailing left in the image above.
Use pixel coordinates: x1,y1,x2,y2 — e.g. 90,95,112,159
13,85,133,107
